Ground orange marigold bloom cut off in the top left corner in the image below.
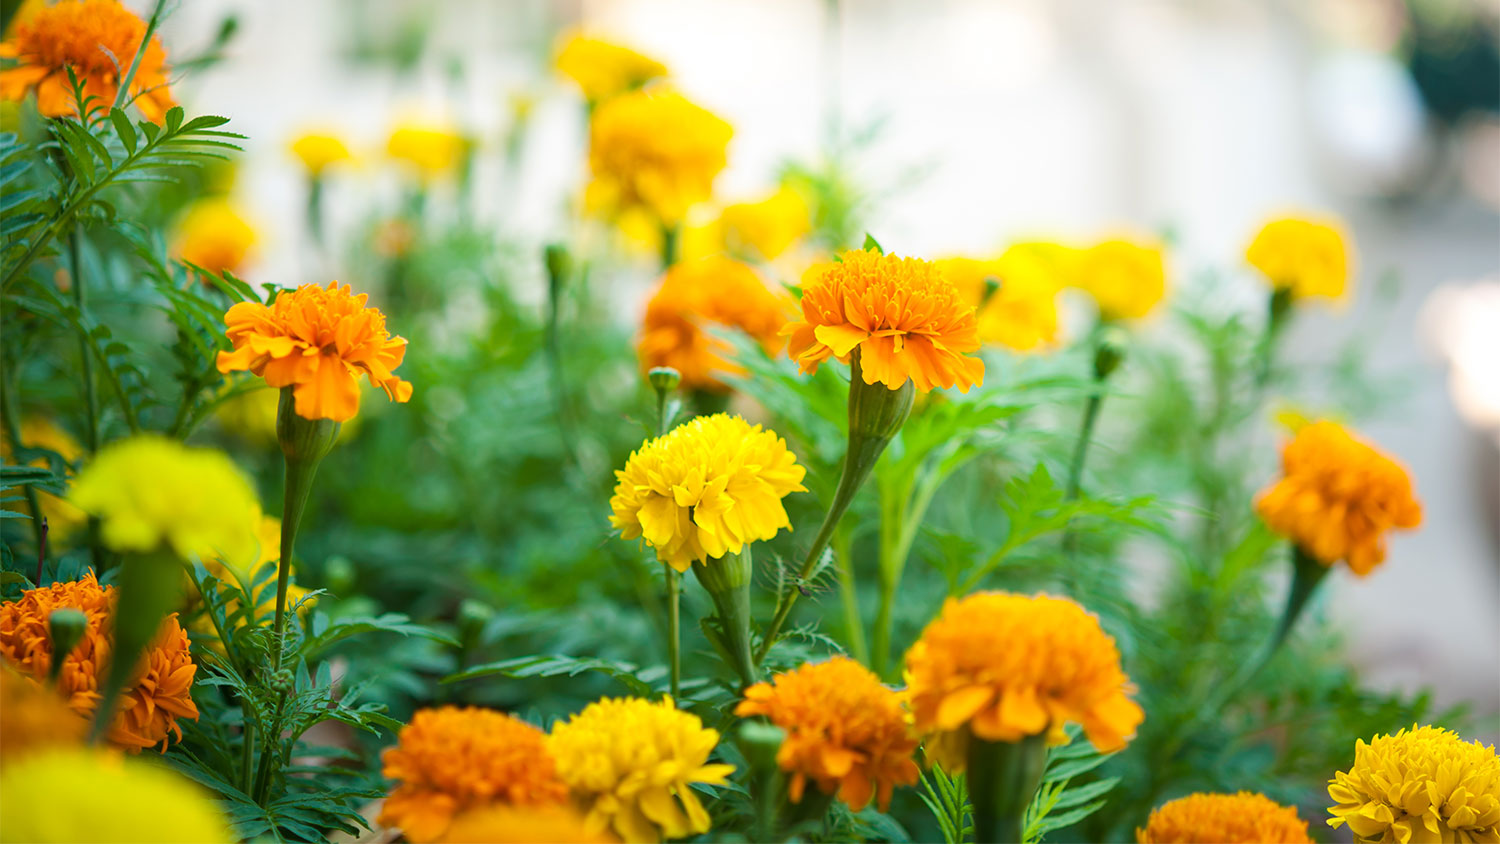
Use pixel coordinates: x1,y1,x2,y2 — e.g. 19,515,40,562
0,0,174,123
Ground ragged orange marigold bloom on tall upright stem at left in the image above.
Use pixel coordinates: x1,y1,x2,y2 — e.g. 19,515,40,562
219,282,411,421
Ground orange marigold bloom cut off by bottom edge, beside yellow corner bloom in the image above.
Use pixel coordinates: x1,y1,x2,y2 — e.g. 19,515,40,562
1136,792,1313,844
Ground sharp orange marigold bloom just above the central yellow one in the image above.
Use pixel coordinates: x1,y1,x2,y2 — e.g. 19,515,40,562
782,249,984,393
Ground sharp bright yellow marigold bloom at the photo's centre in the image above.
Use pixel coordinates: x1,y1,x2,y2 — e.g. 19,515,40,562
609,414,807,571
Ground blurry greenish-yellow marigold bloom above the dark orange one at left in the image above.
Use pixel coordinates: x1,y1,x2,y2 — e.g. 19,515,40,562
69,435,261,561
